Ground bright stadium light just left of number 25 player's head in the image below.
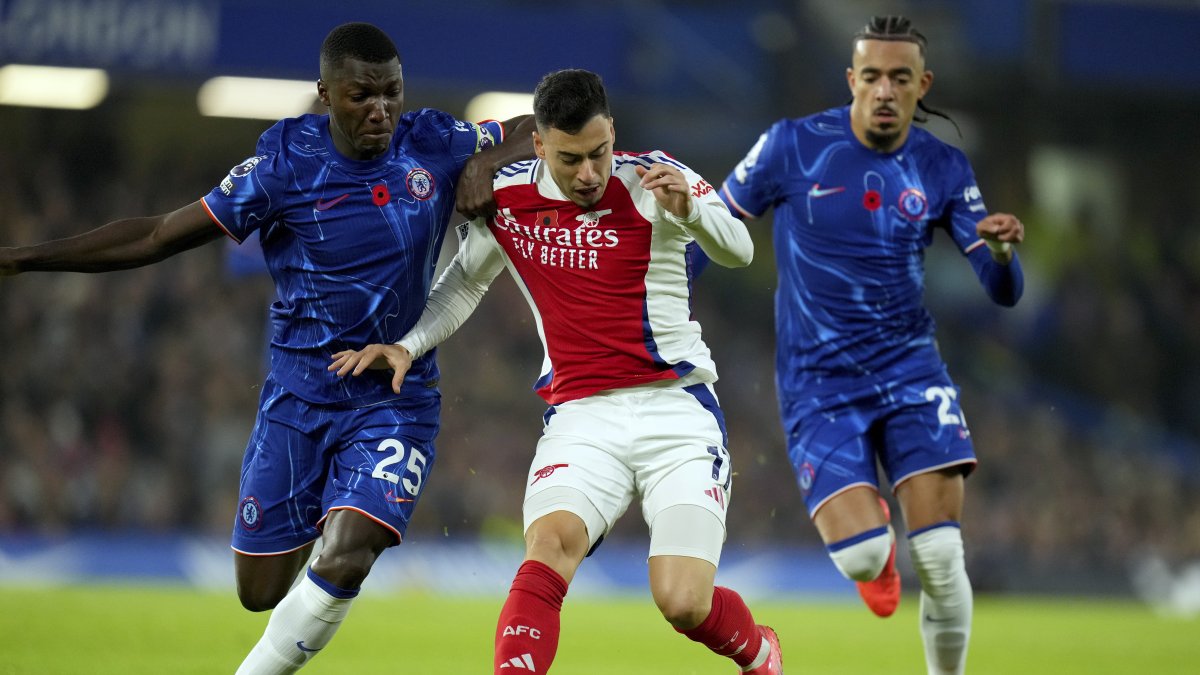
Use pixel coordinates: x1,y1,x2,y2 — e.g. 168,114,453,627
196,76,317,120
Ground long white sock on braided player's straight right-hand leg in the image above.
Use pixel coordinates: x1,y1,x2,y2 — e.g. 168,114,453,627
908,521,973,675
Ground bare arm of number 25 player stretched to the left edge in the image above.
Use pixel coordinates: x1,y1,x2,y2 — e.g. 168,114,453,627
0,201,222,275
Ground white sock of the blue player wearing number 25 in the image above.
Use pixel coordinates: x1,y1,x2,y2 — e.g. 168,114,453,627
238,567,359,675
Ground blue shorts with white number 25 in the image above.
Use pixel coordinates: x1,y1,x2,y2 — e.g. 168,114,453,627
232,377,442,555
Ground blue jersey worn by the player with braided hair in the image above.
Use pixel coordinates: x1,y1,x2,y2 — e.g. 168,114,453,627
721,106,986,399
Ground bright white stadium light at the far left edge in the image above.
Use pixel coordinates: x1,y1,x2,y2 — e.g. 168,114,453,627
0,64,108,110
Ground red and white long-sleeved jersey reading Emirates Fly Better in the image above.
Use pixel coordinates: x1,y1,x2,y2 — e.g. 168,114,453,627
400,151,752,405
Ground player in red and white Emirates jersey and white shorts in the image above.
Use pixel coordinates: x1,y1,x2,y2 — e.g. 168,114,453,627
330,70,782,674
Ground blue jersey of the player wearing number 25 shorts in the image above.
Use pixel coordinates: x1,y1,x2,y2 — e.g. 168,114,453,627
203,109,503,407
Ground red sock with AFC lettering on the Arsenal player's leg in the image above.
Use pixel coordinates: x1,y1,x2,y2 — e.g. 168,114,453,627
492,560,566,675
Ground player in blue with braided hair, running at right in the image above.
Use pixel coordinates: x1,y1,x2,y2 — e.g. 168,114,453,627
721,17,1024,674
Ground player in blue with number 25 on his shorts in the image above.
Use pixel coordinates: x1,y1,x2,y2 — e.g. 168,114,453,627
0,23,533,674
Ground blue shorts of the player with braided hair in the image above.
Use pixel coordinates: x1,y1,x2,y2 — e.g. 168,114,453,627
780,369,976,516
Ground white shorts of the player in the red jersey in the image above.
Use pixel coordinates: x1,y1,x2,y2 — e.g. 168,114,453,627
523,383,732,565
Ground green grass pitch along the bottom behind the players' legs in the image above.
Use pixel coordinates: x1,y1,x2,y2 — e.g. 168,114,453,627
0,586,1200,675
